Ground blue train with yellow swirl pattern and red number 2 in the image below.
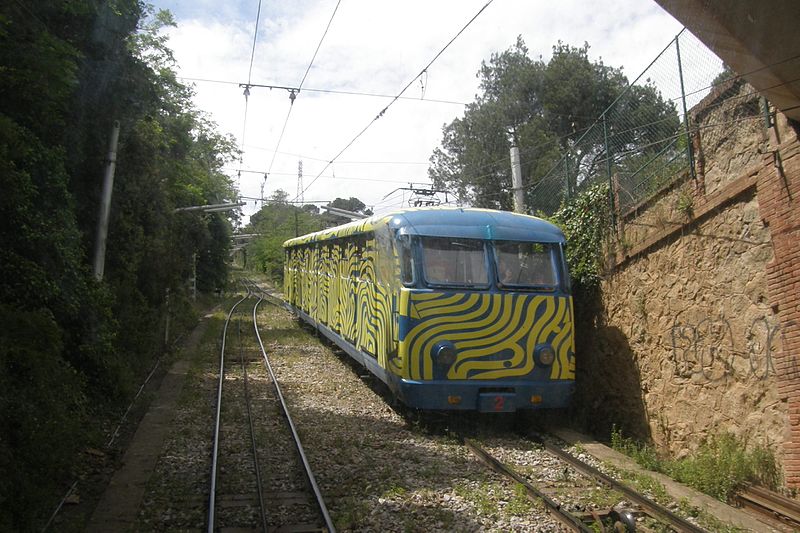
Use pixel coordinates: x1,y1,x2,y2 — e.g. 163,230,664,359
283,208,575,412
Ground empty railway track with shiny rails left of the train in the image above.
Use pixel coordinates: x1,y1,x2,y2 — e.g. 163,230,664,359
206,282,334,532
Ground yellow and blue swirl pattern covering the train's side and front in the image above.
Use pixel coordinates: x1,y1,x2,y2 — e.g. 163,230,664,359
284,235,575,380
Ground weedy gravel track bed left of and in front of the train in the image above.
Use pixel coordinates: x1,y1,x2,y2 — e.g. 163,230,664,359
51,276,790,532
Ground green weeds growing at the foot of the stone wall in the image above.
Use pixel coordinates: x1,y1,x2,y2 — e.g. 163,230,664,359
611,429,780,501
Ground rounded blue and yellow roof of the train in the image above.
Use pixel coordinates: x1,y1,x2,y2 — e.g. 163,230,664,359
283,207,565,246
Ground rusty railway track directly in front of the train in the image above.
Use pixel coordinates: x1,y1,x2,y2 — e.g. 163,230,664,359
463,432,706,533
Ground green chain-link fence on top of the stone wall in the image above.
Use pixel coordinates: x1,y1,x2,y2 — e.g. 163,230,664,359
529,26,744,216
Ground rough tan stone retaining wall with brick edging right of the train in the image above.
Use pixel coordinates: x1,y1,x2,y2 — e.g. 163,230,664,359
578,78,800,486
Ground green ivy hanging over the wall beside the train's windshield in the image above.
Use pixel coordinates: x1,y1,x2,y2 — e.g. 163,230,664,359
553,183,611,288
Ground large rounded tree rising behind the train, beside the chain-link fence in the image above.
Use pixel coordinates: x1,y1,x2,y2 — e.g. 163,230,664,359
428,37,678,213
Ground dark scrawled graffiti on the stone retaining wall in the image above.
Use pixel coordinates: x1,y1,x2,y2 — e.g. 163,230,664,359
670,317,781,382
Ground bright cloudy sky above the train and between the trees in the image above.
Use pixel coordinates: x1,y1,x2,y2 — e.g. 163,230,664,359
153,0,682,223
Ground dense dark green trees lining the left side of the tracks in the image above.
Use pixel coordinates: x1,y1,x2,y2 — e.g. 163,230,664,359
0,0,236,530
